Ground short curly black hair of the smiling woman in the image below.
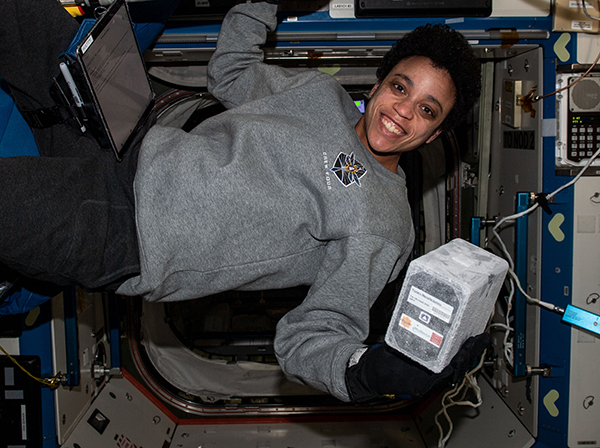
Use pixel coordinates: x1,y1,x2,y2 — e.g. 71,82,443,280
377,24,481,131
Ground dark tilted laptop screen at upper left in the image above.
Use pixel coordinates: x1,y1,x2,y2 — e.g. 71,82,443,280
78,3,154,152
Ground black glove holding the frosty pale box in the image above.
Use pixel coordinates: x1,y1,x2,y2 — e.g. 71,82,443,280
346,333,490,404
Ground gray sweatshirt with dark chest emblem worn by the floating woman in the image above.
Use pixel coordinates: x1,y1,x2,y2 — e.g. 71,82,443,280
119,3,413,400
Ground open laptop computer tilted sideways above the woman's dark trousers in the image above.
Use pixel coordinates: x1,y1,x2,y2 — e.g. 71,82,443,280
60,0,154,160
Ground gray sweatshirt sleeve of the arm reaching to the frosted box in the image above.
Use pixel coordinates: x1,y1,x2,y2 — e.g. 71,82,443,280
275,236,405,401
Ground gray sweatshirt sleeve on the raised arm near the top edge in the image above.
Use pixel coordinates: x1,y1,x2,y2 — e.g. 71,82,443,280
208,2,319,109
